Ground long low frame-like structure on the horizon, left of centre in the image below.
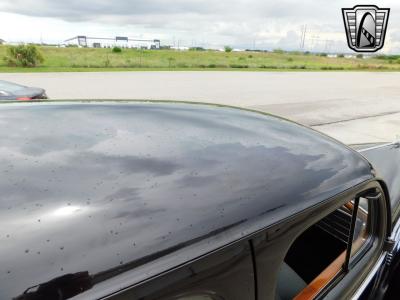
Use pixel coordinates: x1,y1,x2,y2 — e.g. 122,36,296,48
64,35,160,49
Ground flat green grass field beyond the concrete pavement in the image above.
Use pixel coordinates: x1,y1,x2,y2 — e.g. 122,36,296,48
0,46,400,72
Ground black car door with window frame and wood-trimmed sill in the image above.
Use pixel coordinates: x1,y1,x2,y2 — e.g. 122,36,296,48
253,181,389,300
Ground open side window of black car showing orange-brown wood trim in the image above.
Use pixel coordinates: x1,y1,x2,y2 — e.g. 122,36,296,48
277,198,371,300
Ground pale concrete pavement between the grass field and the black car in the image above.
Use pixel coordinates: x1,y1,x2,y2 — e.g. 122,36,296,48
0,71,400,143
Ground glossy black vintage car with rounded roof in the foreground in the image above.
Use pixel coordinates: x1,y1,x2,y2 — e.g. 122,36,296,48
0,101,400,300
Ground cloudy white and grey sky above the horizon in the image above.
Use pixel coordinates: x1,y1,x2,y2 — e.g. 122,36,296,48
0,0,400,53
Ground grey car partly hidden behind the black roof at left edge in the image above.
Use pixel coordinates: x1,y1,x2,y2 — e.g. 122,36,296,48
0,80,47,101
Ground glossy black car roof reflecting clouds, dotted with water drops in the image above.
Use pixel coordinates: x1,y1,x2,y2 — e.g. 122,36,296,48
0,102,374,299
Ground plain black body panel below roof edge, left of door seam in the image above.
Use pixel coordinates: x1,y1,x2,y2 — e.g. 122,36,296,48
110,241,256,300
